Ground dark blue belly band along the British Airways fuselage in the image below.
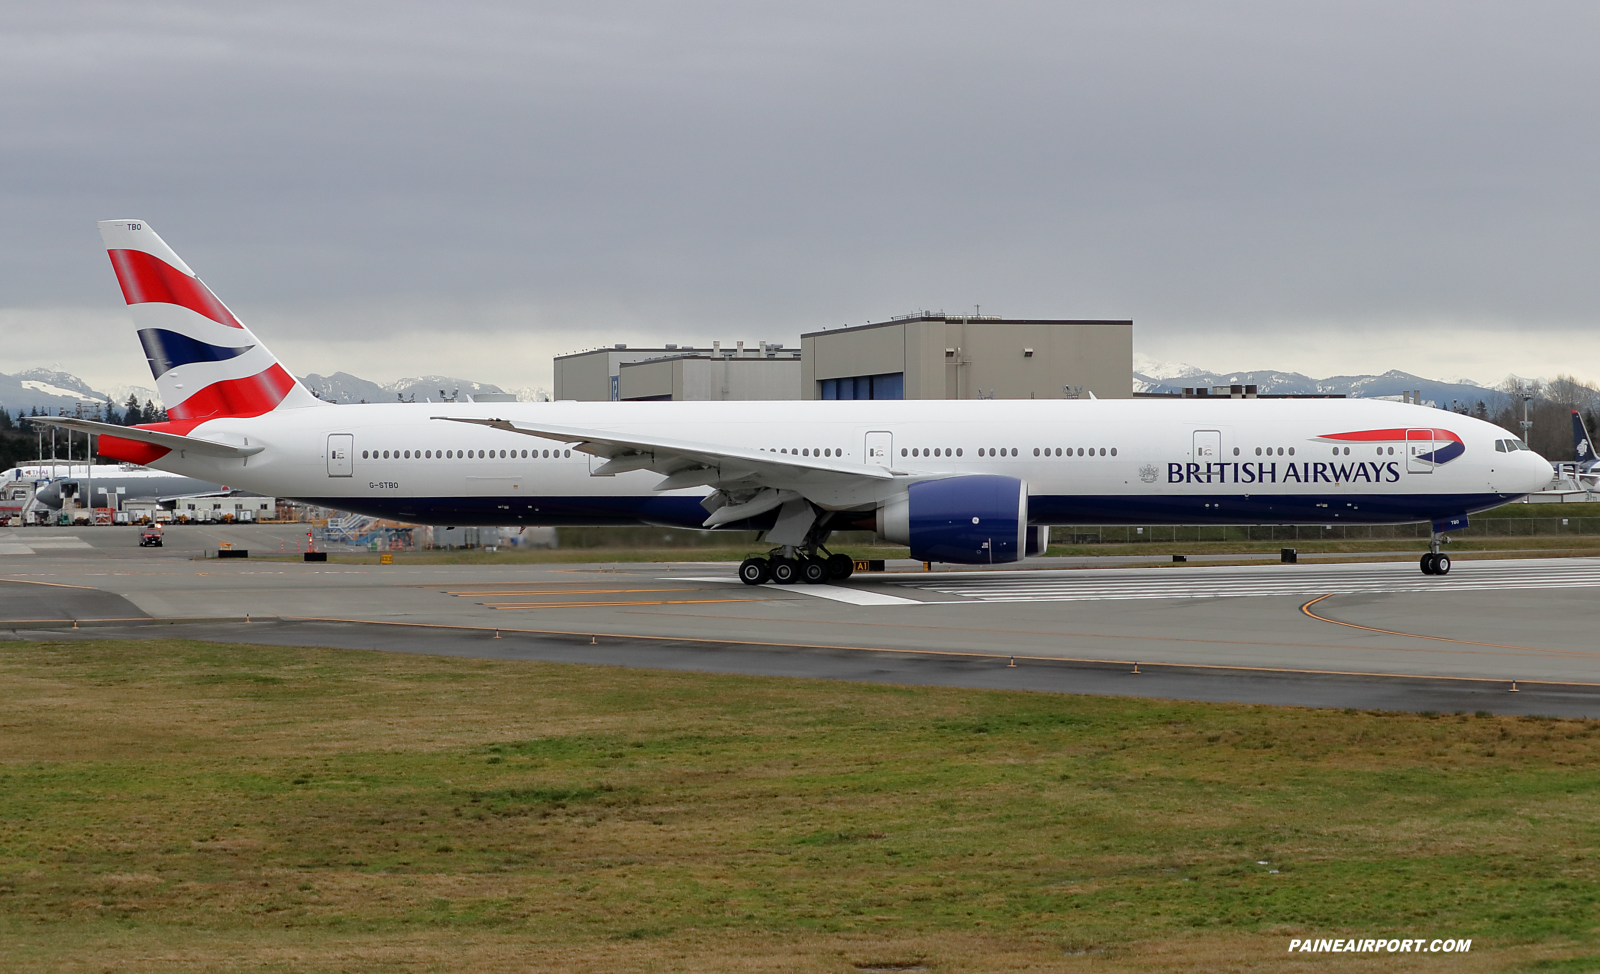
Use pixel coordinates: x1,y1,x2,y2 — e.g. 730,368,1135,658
298,494,1514,531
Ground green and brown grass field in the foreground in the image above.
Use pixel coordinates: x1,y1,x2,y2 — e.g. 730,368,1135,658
0,641,1600,974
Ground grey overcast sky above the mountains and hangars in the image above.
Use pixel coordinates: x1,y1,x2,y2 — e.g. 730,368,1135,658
0,0,1600,387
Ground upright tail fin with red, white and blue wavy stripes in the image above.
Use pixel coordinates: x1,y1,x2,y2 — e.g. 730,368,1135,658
99,219,322,433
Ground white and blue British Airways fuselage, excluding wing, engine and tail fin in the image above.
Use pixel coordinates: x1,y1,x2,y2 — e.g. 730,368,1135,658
131,400,1550,526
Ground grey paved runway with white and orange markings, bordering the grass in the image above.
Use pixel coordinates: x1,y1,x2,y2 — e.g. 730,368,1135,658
0,534,1600,717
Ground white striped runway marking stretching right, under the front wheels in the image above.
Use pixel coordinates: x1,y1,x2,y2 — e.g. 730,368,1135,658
880,558,1600,605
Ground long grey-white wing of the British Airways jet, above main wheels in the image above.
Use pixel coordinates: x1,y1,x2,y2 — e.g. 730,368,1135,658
434,416,921,526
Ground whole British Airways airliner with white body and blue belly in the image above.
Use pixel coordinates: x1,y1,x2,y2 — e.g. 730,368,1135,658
34,219,1550,575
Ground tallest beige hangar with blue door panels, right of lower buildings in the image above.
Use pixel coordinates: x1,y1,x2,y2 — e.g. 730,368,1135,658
800,313,1133,400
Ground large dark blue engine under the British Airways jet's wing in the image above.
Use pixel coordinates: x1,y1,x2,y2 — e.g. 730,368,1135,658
878,475,1024,565
